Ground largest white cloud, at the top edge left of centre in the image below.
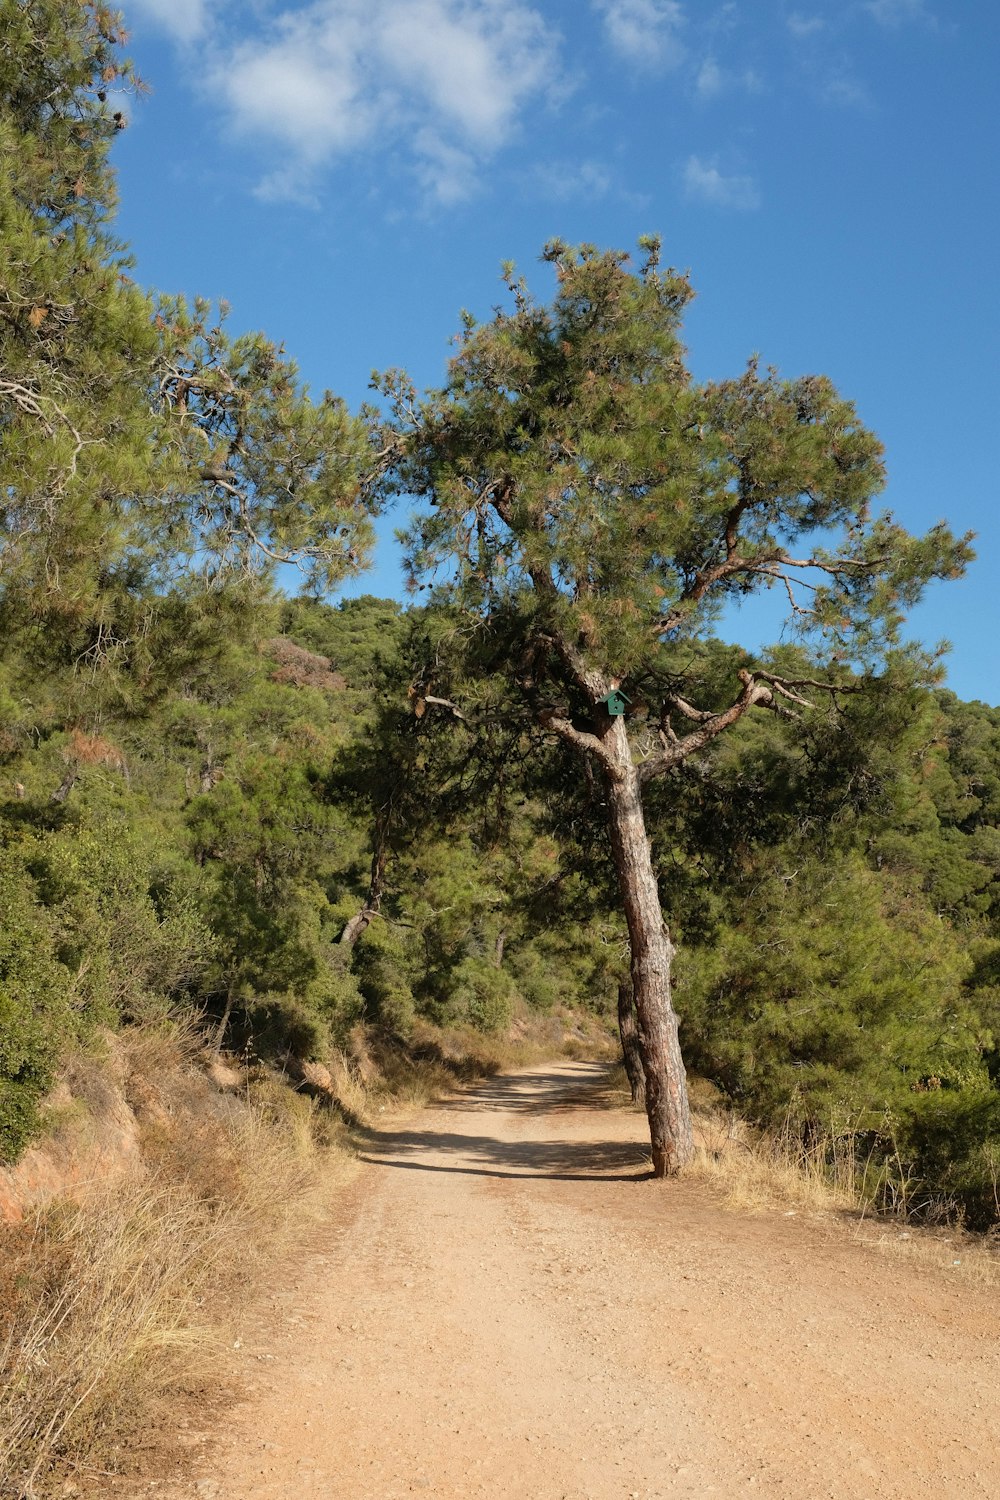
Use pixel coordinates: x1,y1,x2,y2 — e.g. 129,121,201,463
202,0,561,203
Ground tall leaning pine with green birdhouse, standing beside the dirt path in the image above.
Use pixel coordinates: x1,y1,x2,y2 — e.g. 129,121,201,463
373,240,969,1176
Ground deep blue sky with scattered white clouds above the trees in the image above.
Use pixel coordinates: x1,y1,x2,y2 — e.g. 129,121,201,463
117,0,1000,704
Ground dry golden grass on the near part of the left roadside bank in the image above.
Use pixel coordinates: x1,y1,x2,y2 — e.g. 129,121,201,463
0,1038,335,1500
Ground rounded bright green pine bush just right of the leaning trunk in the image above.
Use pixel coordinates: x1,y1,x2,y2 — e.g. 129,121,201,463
678,851,985,1124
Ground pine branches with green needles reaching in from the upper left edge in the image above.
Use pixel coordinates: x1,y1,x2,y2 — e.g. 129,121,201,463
0,0,379,665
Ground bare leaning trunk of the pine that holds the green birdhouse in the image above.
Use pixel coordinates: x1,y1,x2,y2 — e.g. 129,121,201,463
603,719,694,1178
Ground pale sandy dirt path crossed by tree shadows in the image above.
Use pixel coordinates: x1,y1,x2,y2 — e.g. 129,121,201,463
154,1064,1000,1500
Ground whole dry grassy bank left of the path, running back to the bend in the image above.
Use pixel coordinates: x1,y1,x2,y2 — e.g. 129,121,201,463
0,1019,601,1500
